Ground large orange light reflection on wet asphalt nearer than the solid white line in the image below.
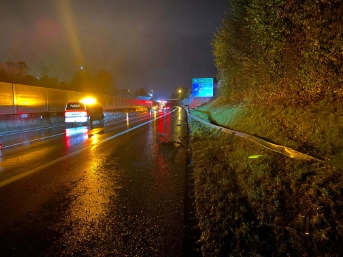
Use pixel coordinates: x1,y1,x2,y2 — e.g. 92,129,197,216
62,151,118,245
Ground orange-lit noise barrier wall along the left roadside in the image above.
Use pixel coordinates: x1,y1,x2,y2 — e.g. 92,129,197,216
0,82,152,115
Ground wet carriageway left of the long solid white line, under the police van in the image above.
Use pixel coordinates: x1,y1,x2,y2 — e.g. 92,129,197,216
0,112,157,182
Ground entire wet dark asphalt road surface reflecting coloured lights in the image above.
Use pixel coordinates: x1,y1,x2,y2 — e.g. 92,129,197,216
0,107,191,256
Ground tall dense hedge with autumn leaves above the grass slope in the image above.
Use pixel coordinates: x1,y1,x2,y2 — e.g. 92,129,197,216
212,0,343,105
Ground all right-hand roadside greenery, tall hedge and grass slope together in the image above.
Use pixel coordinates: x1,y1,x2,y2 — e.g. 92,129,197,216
191,0,343,256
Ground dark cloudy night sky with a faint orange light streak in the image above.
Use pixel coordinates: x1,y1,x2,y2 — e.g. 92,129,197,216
0,0,228,98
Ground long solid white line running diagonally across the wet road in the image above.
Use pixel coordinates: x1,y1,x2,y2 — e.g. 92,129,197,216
0,109,176,187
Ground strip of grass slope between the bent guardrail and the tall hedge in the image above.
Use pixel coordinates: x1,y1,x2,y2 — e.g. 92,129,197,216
191,98,343,164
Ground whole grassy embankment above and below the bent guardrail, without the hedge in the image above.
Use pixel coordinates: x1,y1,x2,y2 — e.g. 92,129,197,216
191,95,343,256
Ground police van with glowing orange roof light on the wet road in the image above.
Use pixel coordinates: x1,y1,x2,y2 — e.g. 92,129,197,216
64,100,105,126
